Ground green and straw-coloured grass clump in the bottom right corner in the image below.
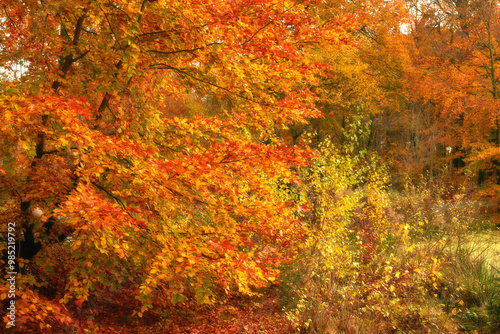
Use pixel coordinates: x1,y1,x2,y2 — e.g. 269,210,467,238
436,230,500,333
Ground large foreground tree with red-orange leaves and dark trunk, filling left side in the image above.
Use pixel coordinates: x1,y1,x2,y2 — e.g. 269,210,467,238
0,0,352,323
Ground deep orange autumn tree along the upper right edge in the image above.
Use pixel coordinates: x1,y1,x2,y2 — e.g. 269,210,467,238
398,1,499,188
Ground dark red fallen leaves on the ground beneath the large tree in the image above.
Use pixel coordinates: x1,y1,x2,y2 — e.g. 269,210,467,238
84,290,294,334
